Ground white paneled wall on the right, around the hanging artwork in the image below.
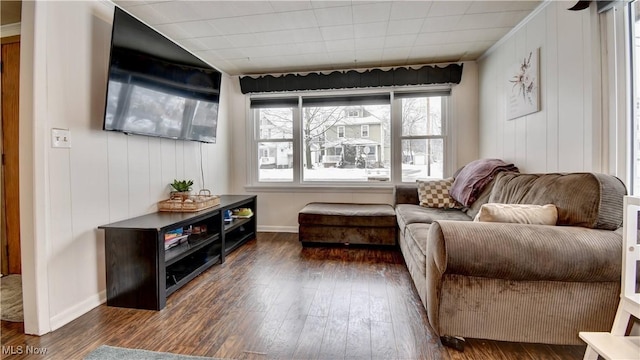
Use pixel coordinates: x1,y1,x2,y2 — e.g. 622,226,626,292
478,1,601,172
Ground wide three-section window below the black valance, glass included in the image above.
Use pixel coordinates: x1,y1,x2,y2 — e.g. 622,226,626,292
248,90,449,185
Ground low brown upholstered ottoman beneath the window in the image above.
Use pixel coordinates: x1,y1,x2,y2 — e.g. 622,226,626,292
298,202,397,246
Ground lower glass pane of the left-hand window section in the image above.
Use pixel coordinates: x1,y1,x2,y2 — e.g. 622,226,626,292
258,141,293,181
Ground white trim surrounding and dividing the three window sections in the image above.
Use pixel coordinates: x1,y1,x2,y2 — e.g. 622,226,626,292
244,85,456,190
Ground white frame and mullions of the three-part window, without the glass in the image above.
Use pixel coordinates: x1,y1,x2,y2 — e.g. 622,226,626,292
245,85,455,191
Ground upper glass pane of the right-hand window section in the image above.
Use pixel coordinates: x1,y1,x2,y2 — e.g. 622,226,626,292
402,96,443,136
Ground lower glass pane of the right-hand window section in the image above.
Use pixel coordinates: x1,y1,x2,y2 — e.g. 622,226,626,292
402,139,444,182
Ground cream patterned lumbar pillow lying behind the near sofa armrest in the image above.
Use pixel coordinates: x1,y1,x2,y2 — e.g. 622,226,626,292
473,203,558,225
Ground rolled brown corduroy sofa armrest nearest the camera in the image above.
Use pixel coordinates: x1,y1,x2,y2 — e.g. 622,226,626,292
427,221,622,282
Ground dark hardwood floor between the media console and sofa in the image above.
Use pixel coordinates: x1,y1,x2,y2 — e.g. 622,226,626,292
0,233,585,360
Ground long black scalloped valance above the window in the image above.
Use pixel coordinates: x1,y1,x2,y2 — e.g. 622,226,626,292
240,64,462,94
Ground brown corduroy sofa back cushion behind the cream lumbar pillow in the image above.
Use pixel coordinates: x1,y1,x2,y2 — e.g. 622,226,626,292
489,172,626,230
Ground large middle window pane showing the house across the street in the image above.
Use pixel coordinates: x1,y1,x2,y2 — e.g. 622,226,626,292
302,104,391,181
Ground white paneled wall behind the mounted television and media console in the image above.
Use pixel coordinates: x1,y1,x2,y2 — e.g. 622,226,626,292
20,1,230,333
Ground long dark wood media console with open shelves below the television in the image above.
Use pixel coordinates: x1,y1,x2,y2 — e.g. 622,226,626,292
98,195,257,310
